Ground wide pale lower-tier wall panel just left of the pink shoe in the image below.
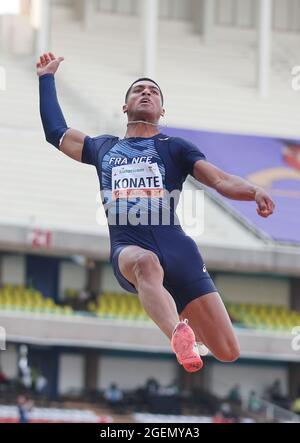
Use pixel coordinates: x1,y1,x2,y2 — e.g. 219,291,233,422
97,356,177,390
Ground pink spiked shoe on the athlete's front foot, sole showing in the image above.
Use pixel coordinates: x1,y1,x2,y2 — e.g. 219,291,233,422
171,320,203,372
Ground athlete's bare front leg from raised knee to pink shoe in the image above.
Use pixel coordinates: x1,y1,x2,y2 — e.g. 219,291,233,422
118,246,179,340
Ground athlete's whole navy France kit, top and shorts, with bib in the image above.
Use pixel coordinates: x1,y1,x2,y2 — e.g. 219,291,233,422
82,134,216,314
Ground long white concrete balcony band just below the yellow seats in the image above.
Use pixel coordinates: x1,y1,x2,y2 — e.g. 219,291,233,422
0,311,299,360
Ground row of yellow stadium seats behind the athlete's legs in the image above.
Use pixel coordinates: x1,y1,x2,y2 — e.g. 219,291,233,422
0,285,300,331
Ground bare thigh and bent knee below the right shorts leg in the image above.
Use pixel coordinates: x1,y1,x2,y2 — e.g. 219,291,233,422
180,292,240,362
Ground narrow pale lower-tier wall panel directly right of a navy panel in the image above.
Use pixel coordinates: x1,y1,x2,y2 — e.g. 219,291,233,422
58,354,84,394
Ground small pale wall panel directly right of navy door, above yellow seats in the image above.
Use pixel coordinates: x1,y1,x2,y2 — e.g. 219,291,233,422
59,262,87,299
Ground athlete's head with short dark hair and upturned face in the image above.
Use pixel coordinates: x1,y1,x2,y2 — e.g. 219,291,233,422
123,81,165,122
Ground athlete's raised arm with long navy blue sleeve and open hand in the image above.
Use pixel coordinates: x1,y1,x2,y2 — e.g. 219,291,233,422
36,52,86,162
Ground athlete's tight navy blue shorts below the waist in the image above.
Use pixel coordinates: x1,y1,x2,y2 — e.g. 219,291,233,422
111,226,217,314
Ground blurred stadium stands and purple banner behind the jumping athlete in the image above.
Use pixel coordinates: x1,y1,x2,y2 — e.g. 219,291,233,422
0,0,300,423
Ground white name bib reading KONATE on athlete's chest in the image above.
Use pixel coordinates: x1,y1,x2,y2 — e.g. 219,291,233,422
111,163,164,200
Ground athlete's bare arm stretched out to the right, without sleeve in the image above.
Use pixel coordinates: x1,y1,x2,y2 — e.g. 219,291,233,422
193,160,275,217
